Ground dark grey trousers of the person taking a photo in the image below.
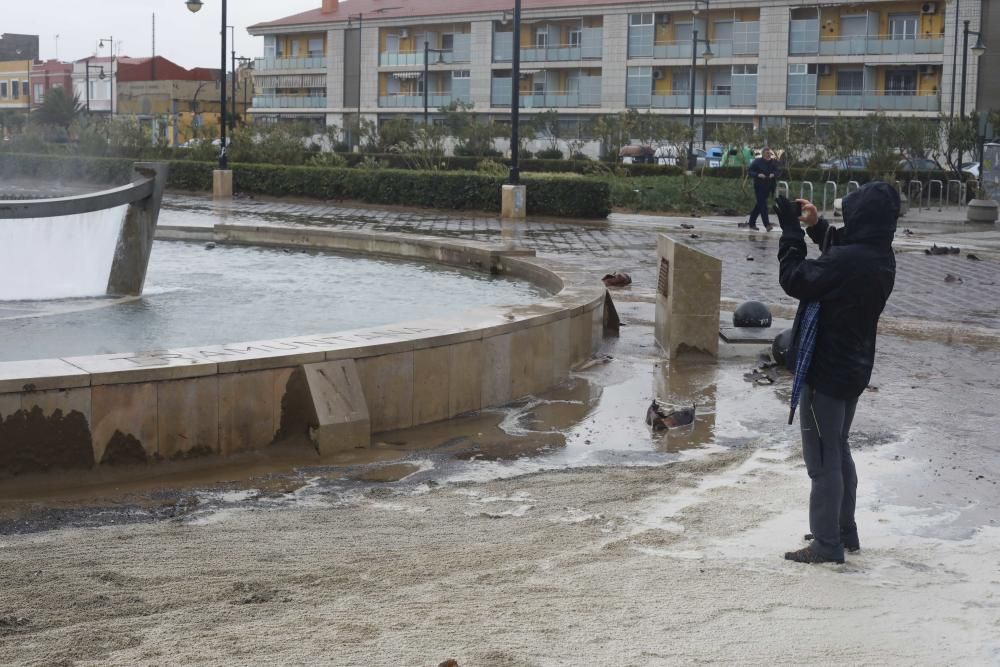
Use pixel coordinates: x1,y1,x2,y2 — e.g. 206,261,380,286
799,385,858,559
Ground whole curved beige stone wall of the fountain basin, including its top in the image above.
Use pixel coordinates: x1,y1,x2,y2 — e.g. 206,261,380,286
0,225,606,476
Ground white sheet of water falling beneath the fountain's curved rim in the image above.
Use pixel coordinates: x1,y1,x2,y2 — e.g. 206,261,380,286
0,205,128,301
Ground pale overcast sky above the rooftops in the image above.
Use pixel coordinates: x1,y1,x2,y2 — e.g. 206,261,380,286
6,0,321,67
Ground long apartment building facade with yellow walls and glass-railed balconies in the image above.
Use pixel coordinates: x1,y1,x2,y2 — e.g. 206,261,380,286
250,0,983,136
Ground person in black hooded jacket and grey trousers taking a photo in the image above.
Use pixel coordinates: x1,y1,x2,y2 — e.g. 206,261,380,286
775,182,900,563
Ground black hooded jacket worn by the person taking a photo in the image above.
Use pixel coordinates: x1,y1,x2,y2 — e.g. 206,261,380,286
778,182,899,399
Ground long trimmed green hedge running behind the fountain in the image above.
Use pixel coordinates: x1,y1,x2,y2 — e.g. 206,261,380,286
0,154,611,219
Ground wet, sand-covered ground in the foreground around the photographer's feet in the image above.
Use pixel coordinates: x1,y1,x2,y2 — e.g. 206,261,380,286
0,300,1000,666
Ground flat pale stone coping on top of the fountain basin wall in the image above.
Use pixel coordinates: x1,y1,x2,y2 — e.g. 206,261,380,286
0,225,605,394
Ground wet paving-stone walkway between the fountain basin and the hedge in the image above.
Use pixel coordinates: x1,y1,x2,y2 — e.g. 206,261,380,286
160,195,1000,328
